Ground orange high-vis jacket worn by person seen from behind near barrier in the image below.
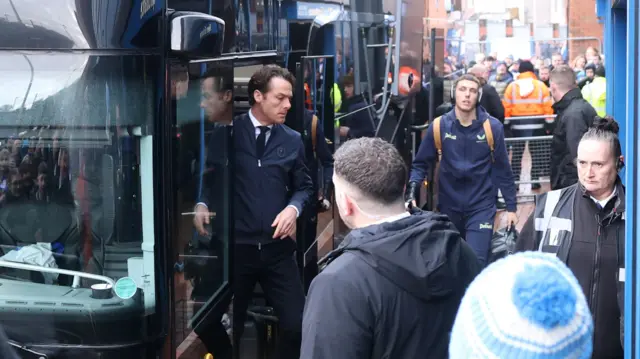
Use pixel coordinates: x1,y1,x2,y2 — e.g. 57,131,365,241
502,72,553,117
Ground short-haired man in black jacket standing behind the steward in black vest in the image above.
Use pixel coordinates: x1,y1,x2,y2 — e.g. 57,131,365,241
547,65,597,189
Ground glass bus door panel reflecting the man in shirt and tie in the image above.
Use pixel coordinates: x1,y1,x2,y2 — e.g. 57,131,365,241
173,62,234,352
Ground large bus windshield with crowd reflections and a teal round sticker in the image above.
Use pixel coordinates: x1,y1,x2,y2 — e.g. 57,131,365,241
0,51,160,345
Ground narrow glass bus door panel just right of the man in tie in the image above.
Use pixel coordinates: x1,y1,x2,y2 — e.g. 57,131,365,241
287,56,340,290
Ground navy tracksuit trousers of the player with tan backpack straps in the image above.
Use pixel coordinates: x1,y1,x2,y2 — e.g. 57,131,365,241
440,205,496,267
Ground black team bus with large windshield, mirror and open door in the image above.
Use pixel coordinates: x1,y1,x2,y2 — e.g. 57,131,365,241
0,0,424,359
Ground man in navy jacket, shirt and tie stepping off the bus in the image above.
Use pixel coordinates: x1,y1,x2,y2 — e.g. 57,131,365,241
194,66,313,359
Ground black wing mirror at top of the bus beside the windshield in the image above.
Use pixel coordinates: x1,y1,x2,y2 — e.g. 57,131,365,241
169,11,225,57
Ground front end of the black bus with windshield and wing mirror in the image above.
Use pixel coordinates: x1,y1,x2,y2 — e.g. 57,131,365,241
0,0,230,358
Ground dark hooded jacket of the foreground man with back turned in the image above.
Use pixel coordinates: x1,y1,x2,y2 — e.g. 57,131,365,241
300,210,480,359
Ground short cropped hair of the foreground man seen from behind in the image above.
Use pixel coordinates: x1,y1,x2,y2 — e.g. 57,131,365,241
333,137,407,204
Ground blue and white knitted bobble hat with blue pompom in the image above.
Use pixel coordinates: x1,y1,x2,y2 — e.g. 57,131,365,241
449,252,593,359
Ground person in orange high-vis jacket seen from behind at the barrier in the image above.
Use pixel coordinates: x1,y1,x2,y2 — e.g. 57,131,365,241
502,61,553,190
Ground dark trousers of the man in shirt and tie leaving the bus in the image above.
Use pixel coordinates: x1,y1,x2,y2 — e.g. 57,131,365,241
233,239,305,359
